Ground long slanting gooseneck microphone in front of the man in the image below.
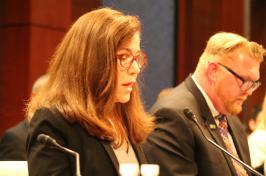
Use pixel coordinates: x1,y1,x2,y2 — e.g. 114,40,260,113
183,108,263,176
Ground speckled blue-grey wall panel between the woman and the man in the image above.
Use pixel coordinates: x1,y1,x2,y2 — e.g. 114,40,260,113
102,0,176,109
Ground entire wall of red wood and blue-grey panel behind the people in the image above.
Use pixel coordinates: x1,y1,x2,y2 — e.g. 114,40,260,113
0,0,266,135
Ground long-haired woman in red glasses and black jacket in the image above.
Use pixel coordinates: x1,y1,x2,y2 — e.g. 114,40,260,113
27,8,154,176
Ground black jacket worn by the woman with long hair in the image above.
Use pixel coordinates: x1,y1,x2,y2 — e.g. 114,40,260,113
27,108,146,176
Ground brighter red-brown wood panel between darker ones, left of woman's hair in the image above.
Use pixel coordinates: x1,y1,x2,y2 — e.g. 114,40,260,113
28,0,72,91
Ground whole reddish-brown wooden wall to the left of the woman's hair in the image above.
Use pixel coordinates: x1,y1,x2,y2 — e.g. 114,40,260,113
0,0,100,134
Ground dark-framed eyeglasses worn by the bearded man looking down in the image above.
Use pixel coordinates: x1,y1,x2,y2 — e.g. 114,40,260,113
218,63,261,92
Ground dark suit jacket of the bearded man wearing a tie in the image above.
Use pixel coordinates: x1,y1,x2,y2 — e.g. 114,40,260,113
144,77,250,176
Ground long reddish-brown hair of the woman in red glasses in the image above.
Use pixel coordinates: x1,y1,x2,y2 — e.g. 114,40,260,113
27,8,154,147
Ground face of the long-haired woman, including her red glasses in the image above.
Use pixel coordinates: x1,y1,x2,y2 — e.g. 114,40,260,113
115,32,143,103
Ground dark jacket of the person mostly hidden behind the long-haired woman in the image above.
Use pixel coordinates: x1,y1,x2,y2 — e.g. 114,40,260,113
0,120,28,161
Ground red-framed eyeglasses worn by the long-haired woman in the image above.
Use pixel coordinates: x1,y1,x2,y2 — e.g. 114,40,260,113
117,49,147,69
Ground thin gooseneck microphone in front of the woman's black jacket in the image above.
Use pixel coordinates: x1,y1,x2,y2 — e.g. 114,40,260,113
37,134,81,176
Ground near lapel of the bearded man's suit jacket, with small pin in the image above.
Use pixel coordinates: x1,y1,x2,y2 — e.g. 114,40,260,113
185,75,235,175
